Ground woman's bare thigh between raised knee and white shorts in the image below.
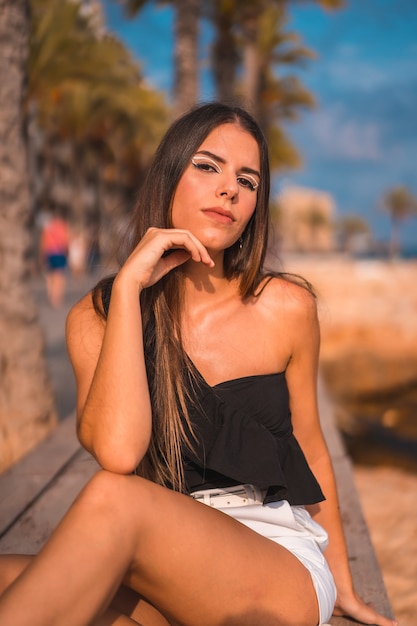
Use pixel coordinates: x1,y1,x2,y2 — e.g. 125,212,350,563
96,475,318,626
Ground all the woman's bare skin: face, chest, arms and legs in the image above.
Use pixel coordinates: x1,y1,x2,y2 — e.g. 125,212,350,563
0,124,394,626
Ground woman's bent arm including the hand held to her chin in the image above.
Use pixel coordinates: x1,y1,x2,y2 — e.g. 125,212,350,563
66,228,213,474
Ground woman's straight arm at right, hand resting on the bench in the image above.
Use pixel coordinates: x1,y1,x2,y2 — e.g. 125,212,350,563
286,290,395,626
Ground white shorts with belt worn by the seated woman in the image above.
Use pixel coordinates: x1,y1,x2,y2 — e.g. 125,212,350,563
192,485,336,626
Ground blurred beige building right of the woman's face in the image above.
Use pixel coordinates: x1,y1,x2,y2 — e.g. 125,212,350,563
277,187,337,252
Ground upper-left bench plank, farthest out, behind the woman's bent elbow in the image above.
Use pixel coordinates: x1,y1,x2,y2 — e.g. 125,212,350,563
0,415,80,537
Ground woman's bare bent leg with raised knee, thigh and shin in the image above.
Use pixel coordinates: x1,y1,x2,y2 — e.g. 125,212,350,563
0,472,318,626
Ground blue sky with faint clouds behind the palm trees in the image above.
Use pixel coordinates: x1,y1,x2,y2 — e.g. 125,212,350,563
103,0,417,249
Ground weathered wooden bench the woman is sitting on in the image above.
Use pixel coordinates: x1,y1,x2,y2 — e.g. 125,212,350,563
0,386,392,626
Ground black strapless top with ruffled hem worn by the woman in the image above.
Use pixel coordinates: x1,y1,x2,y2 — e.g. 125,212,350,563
183,367,324,505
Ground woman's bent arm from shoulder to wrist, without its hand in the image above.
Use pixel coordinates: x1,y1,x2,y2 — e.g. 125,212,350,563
66,280,151,474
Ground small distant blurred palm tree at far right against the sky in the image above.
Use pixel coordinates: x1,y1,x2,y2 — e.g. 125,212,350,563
381,186,417,258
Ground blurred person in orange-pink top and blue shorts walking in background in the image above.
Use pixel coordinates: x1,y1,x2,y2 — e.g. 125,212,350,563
40,213,70,309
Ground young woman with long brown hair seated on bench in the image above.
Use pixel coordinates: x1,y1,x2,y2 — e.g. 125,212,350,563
0,103,395,626
